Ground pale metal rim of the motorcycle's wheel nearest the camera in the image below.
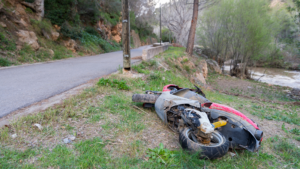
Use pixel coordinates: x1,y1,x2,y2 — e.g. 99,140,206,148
186,129,223,147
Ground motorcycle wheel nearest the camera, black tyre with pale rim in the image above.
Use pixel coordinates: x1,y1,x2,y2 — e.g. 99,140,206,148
179,128,229,160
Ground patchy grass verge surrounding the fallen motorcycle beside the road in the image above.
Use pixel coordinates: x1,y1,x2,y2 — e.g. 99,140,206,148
0,47,300,168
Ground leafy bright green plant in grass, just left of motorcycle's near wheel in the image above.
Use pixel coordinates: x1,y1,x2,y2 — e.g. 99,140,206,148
147,143,175,164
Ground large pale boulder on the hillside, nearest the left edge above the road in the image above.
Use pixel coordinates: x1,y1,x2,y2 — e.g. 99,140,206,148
17,30,40,50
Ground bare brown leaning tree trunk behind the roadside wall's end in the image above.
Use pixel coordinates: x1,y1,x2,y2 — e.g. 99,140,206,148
186,0,199,56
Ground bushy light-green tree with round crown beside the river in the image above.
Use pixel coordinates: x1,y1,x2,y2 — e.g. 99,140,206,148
198,0,282,76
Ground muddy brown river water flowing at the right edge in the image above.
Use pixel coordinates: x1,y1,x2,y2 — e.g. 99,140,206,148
224,65,300,88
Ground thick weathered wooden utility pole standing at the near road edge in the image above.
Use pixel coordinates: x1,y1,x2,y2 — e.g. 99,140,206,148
122,0,131,71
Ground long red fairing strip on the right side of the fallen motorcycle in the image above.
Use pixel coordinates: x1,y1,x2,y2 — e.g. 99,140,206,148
202,103,259,130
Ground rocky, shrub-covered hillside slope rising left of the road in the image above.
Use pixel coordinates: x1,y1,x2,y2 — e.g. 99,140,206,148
0,0,156,66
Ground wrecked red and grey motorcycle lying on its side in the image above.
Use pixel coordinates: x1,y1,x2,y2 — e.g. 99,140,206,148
132,85,263,159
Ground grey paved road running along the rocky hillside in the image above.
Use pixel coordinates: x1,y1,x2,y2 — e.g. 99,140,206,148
0,46,146,118
